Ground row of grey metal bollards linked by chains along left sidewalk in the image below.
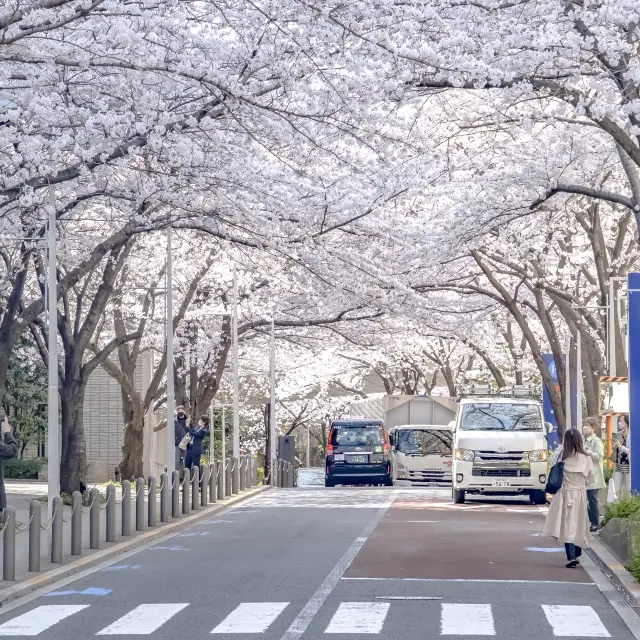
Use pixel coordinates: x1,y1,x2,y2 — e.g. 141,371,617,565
0,454,258,581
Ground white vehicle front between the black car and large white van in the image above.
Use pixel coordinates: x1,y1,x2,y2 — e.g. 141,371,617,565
389,424,453,487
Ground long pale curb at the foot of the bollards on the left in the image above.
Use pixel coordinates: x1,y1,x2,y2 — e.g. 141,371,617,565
0,485,271,607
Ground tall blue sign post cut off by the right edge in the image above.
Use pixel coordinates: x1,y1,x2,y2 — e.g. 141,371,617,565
628,273,640,492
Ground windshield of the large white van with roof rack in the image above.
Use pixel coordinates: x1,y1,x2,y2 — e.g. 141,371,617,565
460,402,542,431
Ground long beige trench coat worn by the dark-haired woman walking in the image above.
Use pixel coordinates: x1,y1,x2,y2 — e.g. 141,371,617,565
542,453,594,549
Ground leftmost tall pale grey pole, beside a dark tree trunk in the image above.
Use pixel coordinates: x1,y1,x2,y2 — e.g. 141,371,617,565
47,186,60,518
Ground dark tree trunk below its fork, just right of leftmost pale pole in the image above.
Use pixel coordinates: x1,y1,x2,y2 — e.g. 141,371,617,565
60,375,87,495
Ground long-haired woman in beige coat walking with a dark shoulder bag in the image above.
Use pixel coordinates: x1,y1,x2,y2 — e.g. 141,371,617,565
542,429,594,569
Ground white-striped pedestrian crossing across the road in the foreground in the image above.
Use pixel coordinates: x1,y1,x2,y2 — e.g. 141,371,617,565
0,601,611,638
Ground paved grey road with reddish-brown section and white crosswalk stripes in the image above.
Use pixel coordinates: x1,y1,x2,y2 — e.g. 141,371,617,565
0,488,639,640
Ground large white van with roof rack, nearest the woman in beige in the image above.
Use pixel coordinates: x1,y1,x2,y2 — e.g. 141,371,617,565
451,396,551,504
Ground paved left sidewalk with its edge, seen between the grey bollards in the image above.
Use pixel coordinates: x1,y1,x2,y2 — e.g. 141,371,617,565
0,481,266,606
